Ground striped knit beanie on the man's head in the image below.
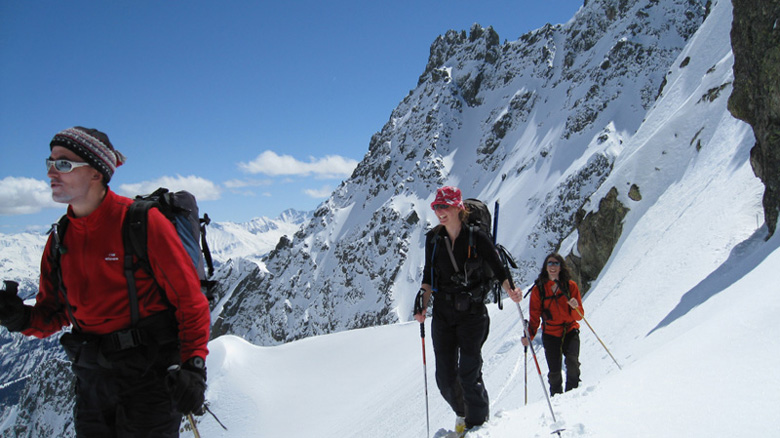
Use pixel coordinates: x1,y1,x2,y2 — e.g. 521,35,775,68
49,126,126,184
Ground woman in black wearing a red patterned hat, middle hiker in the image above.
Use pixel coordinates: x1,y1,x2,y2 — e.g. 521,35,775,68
414,186,522,433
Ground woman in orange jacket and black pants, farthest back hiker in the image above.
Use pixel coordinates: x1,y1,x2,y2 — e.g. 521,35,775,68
510,253,584,395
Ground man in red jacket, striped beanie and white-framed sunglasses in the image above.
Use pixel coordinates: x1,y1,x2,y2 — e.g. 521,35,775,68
0,126,210,437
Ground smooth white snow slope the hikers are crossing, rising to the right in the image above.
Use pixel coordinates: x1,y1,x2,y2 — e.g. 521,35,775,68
190,1,780,438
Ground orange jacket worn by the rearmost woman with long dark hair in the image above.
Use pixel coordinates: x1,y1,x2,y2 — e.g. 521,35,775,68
528,280,585,339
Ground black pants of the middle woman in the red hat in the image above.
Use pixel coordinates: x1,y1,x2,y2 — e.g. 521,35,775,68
431,300,490,425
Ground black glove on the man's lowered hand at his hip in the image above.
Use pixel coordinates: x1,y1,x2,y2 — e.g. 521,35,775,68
165,356,206,415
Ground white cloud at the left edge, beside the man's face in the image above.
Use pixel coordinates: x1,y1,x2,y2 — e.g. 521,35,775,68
0,176,62,216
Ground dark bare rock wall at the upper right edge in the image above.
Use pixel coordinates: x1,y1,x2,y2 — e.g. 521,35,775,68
729,0,780,236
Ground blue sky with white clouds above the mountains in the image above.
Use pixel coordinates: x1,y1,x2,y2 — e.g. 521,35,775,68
0,0,582,233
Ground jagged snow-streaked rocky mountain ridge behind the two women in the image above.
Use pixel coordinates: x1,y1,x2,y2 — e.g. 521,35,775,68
215,0,708,345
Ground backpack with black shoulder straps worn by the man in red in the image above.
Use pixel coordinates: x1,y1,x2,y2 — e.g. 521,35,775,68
51,187,216,329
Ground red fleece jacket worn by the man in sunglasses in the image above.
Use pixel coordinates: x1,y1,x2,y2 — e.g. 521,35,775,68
23,189,210,361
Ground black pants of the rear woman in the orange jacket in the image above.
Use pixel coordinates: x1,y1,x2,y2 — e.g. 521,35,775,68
542,329,580,395
